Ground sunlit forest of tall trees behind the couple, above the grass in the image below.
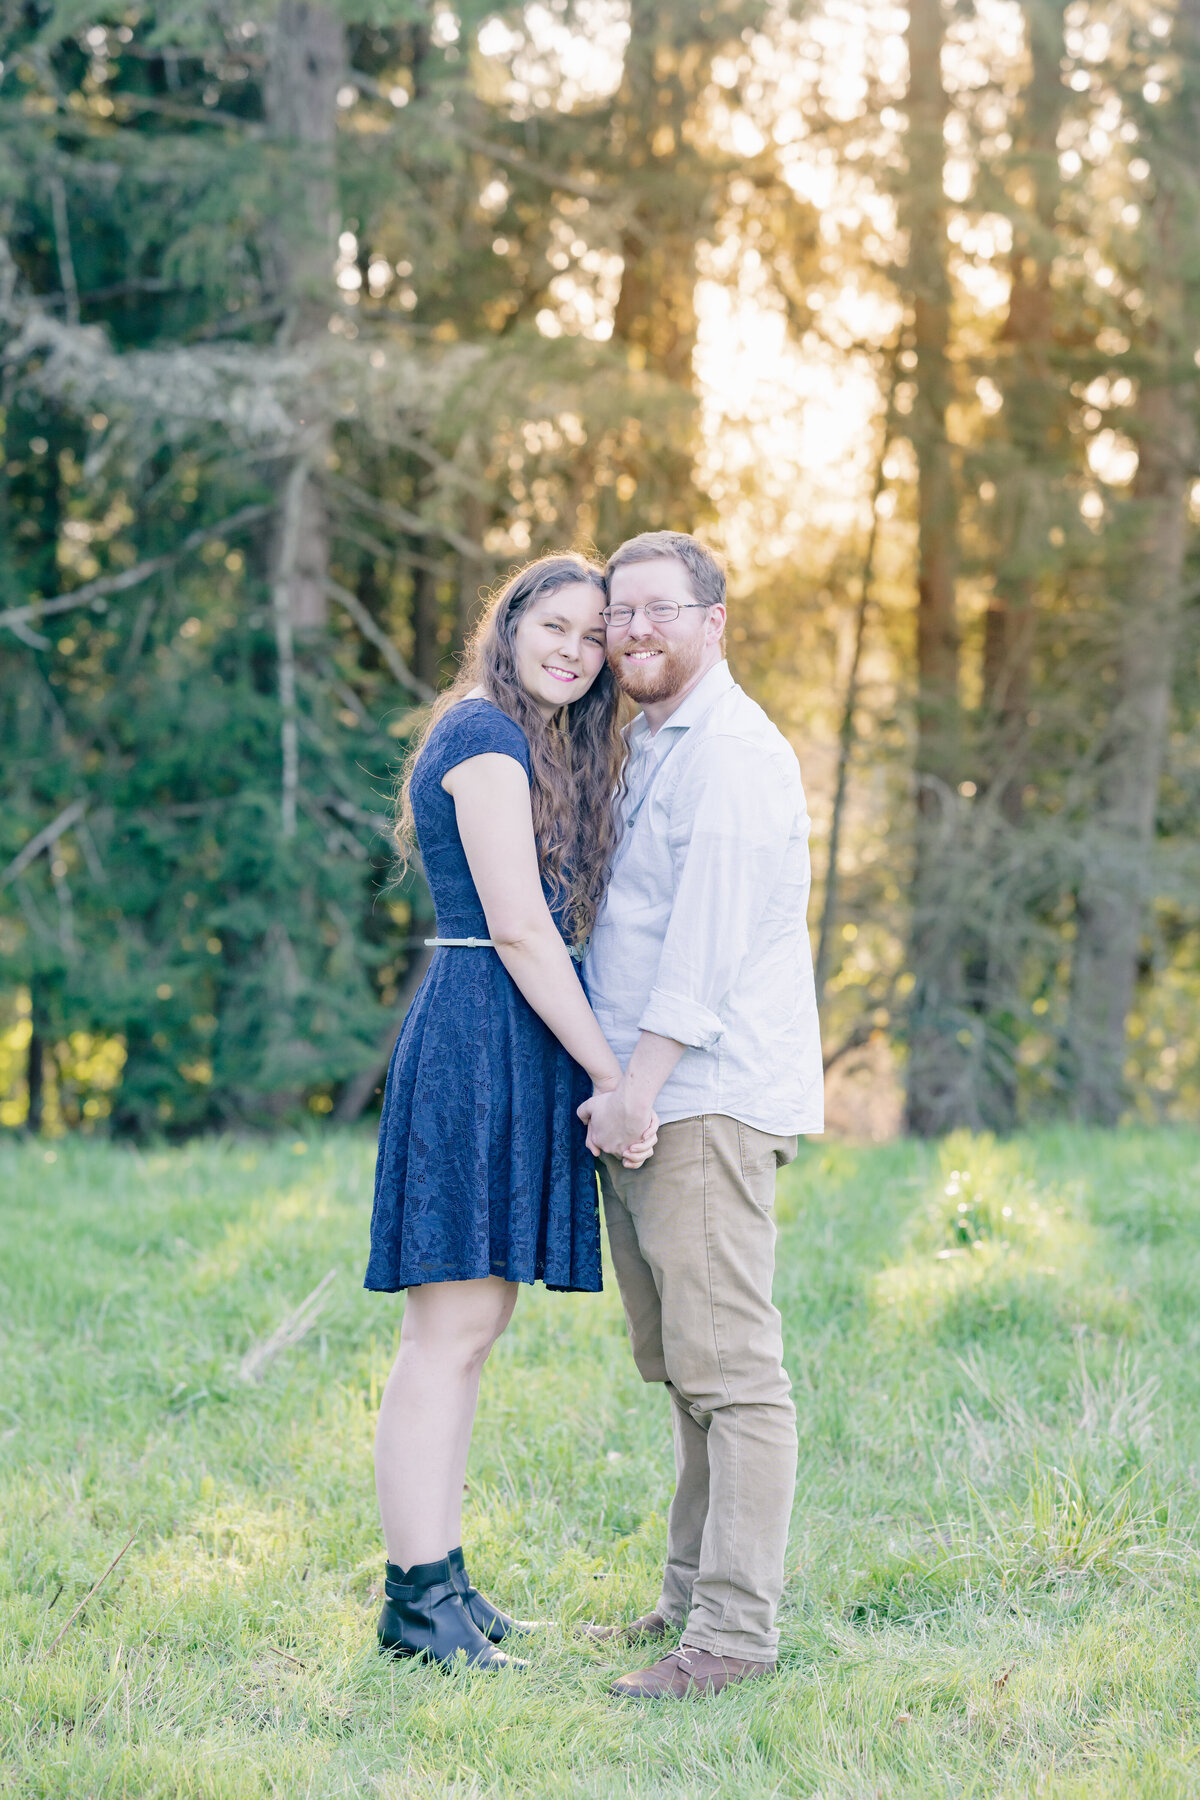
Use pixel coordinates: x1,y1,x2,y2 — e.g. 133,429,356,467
0,0,1200,1136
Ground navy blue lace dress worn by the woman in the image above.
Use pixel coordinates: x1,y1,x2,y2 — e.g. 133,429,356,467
363,700,601,1292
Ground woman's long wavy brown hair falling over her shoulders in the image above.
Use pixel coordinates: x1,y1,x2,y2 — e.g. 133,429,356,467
396,554,624,947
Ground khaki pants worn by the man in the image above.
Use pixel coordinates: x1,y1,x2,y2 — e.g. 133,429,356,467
601,1112,797,1663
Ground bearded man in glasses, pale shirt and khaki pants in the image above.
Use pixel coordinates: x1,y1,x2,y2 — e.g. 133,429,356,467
579,531,822,1699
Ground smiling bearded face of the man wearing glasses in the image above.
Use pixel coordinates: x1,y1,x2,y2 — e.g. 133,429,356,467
608,556,720,706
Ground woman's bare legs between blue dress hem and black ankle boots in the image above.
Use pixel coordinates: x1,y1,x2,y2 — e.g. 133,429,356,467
374,1274,518,1570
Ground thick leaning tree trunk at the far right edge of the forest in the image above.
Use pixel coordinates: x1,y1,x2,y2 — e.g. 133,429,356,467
1069,0,1200,1125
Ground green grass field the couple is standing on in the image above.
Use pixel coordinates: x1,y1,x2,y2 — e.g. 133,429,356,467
0,1130,1200,1800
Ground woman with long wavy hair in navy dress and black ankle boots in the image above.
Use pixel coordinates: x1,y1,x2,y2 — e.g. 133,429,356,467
365,556,655,1667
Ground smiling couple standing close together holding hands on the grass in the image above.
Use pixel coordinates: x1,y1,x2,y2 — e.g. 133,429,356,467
365,531,822,1699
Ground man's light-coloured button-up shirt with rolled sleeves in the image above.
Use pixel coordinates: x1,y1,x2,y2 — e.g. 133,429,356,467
583,662,824,1136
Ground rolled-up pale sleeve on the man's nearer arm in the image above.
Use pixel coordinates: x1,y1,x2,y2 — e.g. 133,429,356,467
639,736,797,1049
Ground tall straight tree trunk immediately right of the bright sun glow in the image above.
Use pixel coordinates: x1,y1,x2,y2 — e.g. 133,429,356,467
901,0,972,1136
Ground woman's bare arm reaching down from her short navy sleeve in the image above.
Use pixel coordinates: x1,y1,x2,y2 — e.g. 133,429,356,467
443,752,621,1091
